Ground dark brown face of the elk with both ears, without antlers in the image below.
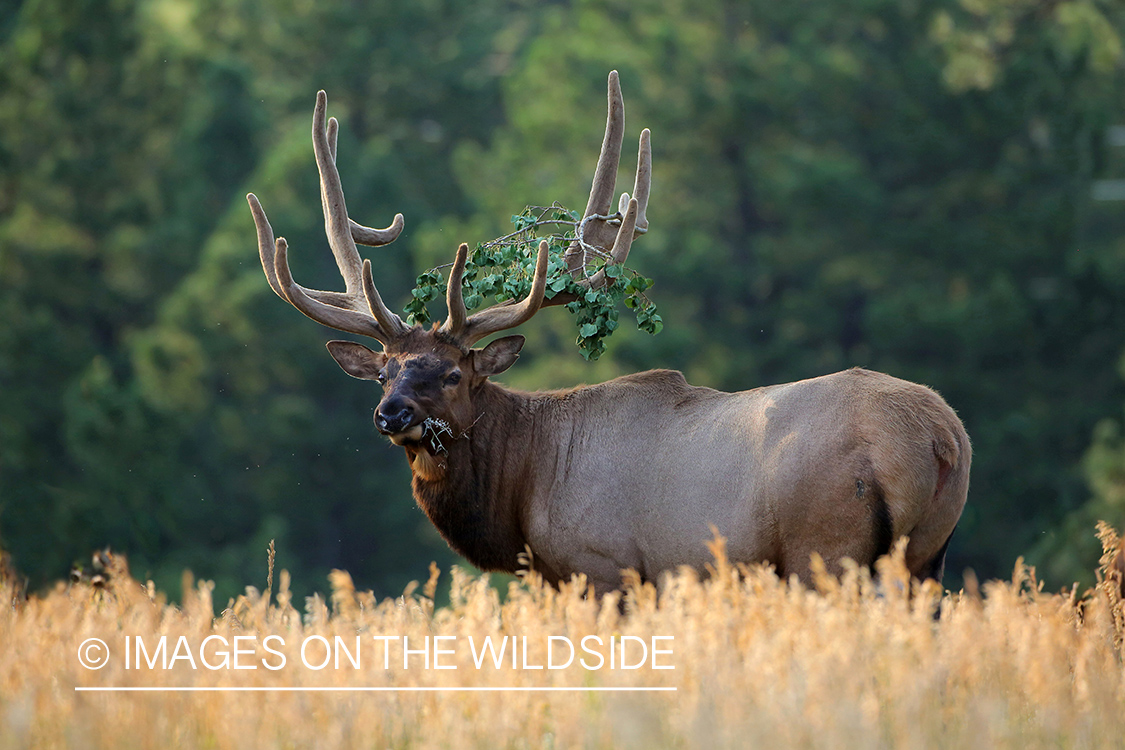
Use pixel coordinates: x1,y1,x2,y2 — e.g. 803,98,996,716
329,328,523,450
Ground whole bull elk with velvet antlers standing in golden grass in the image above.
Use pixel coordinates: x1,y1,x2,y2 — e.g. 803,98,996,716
248,72,971,591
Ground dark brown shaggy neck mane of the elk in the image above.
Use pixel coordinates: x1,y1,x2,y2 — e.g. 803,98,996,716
406,381,544,572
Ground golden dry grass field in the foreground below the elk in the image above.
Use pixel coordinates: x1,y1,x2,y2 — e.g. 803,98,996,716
0,528,1125,750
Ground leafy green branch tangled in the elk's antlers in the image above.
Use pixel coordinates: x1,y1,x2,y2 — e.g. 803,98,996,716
404,204,664,360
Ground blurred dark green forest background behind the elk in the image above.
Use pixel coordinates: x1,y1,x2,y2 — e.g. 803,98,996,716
0,0,1125,600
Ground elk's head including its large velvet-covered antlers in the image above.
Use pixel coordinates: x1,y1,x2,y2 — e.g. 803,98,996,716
246,71,651,478
